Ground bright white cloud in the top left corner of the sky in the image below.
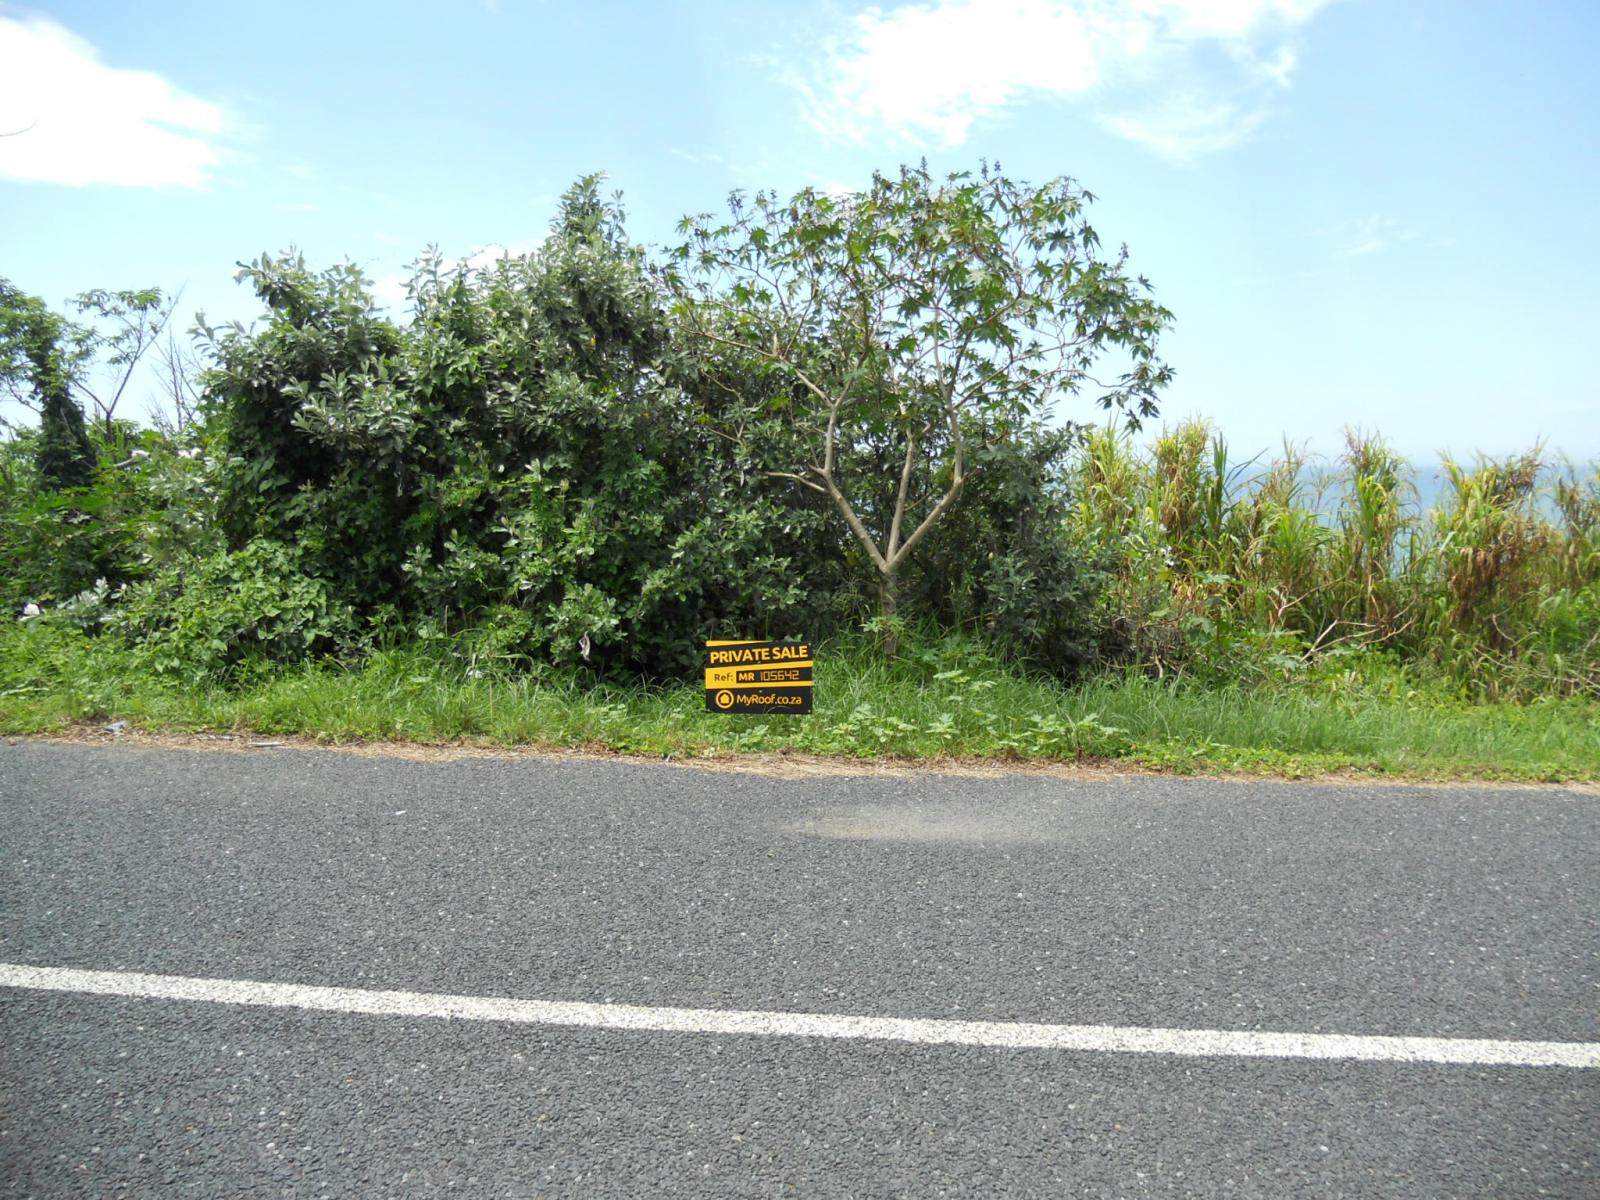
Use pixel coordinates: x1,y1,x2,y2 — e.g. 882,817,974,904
0,18,229,187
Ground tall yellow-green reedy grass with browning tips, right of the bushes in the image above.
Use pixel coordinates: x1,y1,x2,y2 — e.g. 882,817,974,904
1072,422,1600,699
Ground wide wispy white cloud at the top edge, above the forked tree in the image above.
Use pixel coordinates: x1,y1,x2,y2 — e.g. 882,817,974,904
795,0,1330,160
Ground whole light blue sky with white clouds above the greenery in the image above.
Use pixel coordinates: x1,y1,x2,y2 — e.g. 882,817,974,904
0,0,1600,459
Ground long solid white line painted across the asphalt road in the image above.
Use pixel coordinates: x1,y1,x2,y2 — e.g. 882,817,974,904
0,963,1600,1069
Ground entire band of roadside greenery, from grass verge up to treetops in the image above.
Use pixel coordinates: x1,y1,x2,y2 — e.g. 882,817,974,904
0,168,1600,778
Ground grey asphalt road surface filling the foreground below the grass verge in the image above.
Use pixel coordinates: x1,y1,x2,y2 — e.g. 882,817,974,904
0,742,1600,1200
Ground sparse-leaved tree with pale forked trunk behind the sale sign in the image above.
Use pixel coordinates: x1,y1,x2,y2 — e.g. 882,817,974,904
664,163,1171,654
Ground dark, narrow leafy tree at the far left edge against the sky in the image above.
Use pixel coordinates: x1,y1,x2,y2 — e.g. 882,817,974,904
0,278,96,491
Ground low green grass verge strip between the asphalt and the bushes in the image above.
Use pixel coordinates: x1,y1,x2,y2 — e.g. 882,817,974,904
0,624,1600,781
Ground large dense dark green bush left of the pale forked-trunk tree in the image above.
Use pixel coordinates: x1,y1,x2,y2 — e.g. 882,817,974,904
196,179,864,675
